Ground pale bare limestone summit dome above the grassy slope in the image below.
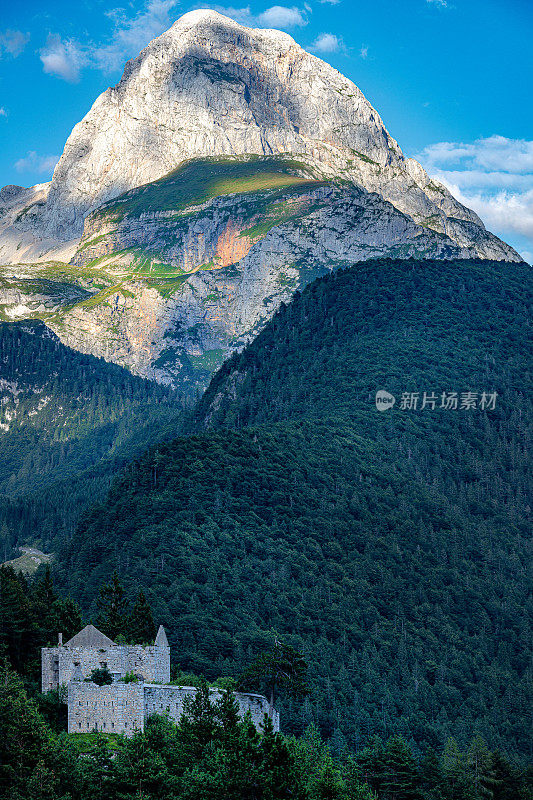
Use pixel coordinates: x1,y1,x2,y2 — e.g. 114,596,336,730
0,11,515,263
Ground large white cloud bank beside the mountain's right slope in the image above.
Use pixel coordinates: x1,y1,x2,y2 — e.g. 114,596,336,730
417,136,533,256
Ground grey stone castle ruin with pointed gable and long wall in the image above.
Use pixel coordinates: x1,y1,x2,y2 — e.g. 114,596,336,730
41,625,279,736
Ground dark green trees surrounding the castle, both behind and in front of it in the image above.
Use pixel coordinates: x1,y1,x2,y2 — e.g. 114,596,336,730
0,567,533,800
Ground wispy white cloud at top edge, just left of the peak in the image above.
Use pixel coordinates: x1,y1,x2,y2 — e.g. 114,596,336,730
93,0,178,72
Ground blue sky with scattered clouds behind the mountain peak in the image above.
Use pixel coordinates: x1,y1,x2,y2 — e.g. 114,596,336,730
0,0,533,261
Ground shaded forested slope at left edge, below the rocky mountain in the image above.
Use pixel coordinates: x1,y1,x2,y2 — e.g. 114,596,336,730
0,322,182,561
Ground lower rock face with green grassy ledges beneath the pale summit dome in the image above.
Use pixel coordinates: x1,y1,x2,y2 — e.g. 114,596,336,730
0,159,507,388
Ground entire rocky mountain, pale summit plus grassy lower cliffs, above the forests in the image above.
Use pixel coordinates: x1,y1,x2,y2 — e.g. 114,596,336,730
0,10,521,384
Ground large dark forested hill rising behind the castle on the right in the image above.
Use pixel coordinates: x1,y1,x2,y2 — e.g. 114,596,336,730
58,261,532,756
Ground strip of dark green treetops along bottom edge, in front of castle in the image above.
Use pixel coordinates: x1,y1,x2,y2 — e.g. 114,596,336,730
4,666,533,800
